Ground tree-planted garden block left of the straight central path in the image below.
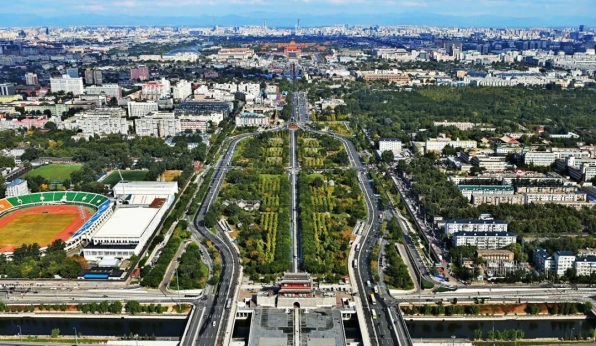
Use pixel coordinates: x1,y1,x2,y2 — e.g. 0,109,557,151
210,132,292,278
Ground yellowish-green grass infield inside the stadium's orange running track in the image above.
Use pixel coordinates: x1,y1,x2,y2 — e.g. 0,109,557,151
0,213,79,247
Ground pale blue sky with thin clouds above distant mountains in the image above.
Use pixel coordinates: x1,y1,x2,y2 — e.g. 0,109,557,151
0,0,596,26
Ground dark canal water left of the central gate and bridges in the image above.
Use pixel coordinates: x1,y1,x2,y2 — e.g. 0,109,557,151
0,317,187,337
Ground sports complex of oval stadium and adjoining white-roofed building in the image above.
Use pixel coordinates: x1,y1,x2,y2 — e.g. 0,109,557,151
0,181,178,261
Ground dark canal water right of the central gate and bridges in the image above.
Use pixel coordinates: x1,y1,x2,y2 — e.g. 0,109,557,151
406,318,596,340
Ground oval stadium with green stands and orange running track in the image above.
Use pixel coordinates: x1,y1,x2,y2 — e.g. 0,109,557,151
0,191,113,257
